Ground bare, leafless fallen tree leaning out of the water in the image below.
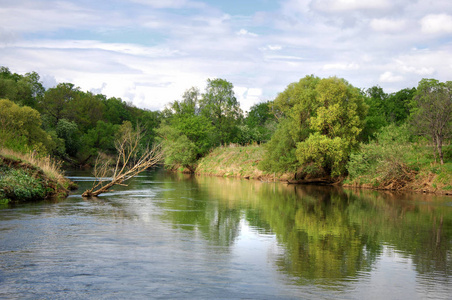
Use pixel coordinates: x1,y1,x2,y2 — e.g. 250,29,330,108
82,125,163,197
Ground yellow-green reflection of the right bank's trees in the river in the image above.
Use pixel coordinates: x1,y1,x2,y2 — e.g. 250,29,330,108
192,177,452,287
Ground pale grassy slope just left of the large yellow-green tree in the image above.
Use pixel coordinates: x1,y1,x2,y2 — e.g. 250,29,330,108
195,144,292,181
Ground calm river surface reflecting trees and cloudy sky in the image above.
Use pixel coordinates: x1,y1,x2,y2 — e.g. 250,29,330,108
0,170,452,300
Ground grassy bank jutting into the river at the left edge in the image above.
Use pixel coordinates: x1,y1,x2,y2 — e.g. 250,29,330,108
0,149,73,204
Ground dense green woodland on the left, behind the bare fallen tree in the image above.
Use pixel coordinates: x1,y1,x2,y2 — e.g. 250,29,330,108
0,67,161,165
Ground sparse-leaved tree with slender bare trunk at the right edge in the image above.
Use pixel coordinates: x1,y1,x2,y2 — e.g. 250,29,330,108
411,79,452,164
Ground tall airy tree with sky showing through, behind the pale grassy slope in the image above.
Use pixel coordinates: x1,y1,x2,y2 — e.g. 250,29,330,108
200,79,243,145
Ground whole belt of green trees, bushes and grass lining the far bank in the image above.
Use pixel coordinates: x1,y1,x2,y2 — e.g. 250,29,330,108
0,67,452,193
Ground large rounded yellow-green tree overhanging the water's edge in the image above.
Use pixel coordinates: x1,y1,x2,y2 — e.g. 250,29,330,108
262,76,367,177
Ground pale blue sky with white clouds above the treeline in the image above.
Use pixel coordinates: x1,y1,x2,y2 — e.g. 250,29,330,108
0,0,452,111
